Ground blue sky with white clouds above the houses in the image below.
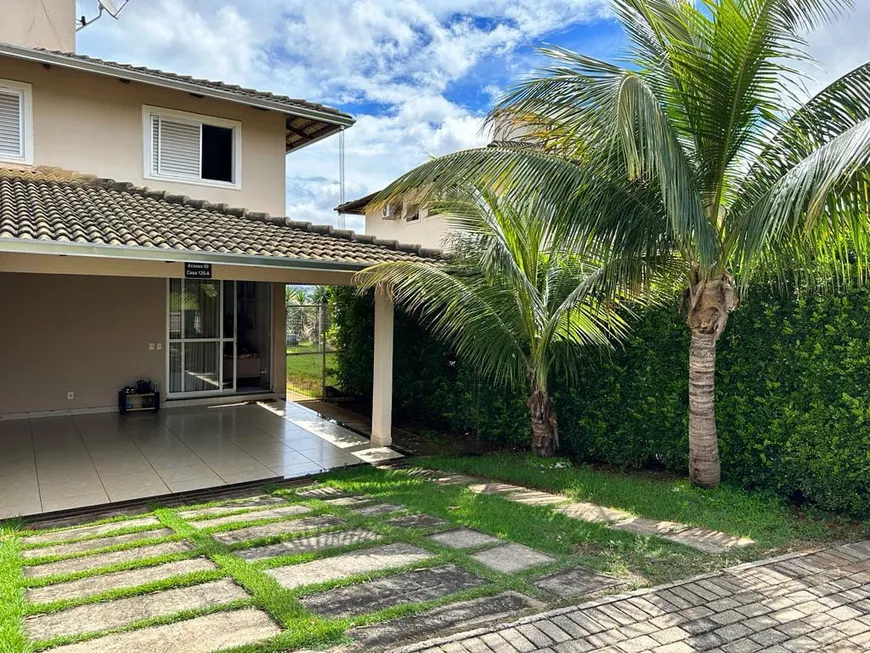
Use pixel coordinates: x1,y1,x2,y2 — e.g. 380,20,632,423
77,0,870,230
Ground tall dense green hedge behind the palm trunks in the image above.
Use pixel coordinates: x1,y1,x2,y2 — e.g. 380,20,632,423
335,289,870,515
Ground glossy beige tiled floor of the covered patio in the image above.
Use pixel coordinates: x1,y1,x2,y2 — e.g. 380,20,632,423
0,402,406,519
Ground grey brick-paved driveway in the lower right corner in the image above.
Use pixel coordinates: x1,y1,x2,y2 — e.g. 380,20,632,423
396,541,870,653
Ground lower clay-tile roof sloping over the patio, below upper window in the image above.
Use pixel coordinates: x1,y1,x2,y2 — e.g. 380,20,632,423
0,167,439,270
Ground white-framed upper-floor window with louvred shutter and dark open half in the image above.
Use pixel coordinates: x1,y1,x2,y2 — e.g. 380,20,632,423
144,107,242,188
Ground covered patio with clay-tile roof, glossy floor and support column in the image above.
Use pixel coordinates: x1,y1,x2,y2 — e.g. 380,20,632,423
0,169,432,518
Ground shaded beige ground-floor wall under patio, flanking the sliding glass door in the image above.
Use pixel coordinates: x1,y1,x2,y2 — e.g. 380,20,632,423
0,273,286,419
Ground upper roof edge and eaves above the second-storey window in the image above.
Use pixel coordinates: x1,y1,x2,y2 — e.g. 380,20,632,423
0,43,354,152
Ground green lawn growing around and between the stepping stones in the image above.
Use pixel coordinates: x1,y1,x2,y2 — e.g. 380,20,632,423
0,455,861,653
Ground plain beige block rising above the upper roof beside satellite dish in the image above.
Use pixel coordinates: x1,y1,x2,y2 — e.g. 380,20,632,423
0,0,75,52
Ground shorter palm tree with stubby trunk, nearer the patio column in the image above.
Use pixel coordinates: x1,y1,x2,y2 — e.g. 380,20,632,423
355,188,668,456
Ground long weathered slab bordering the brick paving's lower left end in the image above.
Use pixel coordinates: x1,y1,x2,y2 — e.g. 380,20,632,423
348,592,540,653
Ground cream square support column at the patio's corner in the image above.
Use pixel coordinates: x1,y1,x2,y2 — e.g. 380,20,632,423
372,288,393,447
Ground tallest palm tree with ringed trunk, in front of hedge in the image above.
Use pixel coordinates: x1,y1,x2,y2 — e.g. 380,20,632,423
380,0,870,487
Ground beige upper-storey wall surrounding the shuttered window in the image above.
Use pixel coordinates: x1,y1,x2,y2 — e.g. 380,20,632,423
0,55,286,215
